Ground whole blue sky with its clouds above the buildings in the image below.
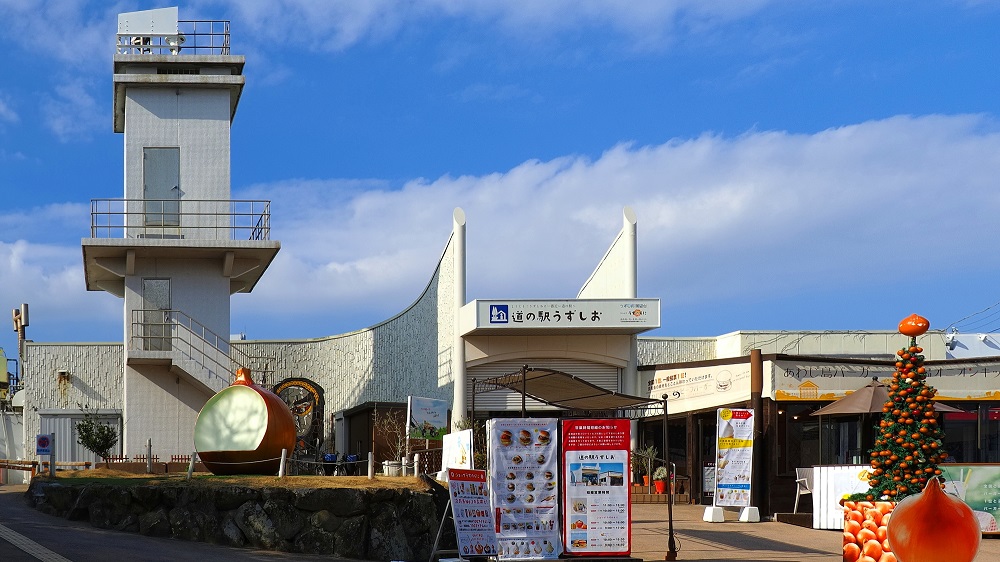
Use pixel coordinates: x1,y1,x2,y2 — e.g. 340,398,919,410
0,0,1000,364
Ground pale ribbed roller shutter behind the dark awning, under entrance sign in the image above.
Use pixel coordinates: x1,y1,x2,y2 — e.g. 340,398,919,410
466,358,621,412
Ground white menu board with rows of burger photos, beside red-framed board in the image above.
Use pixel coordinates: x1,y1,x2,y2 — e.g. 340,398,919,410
487,418,563,560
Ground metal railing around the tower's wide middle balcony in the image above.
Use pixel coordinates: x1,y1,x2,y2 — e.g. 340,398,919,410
90,199,271,240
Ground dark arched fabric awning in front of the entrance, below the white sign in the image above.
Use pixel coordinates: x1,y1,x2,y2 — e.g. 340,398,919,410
473,367,659,410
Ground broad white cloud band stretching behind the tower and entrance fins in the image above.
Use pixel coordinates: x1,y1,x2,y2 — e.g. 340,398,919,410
7,115,1000,339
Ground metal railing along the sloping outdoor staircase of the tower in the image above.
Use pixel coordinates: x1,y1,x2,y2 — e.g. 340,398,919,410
129,309,273,386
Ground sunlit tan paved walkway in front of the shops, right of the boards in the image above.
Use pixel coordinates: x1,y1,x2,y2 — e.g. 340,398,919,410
632,498,1000,562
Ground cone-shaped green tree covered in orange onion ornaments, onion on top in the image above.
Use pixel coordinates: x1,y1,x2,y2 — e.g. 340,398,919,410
852,314,948,501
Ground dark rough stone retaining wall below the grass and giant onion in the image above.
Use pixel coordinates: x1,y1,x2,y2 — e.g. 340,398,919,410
25,478,455,560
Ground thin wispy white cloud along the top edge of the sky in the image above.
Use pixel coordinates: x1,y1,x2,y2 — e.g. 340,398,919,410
196,0,770,51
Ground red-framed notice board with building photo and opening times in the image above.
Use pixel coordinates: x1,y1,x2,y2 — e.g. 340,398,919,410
561,420,632,555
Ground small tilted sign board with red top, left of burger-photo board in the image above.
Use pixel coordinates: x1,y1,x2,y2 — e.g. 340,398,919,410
448,468,499,558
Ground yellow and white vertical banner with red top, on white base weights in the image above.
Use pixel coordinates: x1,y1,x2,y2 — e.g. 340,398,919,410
714,408,754,507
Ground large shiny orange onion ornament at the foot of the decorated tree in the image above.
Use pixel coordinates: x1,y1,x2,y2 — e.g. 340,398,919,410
886,478,982,562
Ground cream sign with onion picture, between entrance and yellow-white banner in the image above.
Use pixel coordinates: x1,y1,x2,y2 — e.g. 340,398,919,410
646,363,750,413
